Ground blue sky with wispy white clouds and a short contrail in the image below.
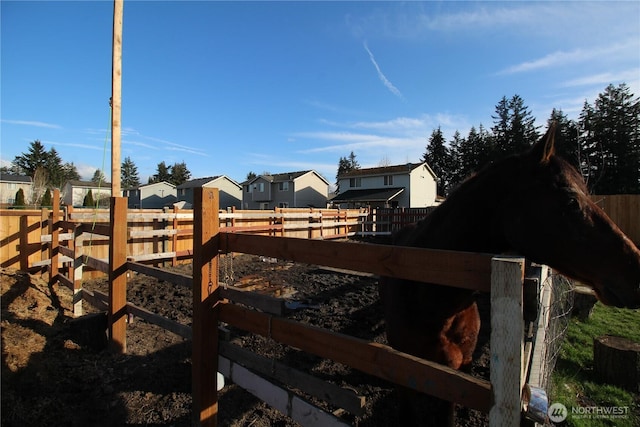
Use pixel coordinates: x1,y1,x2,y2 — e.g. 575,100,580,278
0,0,640,187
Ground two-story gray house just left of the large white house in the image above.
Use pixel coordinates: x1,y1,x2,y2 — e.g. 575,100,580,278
242,170,329,209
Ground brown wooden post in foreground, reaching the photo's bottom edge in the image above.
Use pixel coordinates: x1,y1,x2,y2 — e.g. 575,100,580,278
191,188,220,426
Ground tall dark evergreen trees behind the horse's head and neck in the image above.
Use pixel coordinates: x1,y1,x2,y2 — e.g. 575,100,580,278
336,83,640,196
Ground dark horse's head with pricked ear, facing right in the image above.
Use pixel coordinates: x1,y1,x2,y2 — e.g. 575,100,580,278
498,125,640,308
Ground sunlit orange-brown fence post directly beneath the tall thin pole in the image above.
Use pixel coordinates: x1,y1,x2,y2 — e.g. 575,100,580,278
109,197,127,353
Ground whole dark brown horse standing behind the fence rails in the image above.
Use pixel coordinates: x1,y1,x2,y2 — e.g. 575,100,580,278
380,125,640,425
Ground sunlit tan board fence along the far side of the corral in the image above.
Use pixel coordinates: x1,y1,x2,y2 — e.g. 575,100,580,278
0,202,367,271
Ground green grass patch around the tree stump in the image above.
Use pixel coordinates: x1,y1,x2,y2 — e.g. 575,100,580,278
549,303,640,427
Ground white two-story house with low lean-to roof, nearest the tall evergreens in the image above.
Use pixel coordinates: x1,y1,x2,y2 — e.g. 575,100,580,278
331,163,438,208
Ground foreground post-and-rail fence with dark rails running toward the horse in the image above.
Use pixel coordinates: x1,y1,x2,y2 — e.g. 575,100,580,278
31,189,556,426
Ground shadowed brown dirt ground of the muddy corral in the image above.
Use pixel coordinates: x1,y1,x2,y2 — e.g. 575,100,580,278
0,255,489,427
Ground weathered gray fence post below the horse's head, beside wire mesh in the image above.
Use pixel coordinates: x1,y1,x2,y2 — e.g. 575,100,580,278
489,256,524,427
